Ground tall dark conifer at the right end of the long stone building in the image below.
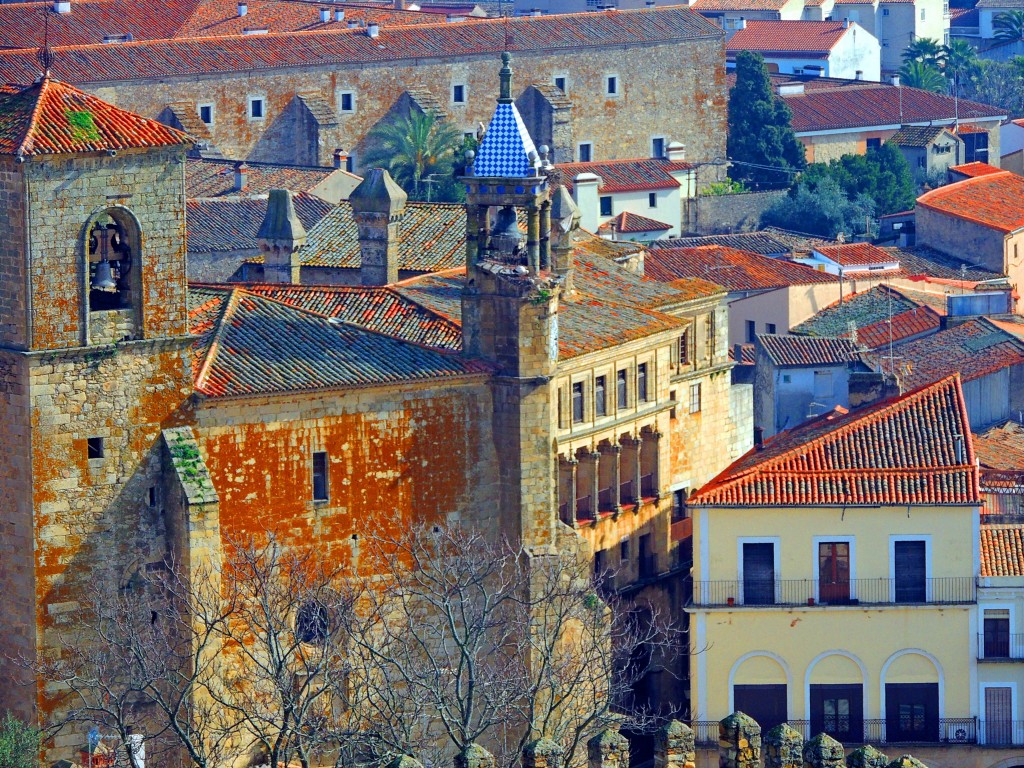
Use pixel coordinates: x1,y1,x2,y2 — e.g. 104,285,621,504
727,51,807,187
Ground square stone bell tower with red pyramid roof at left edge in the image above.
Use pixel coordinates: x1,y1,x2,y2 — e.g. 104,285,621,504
0,75,191,753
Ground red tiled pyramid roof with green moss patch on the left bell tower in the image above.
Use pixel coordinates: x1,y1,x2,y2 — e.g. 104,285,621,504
0,77,193,157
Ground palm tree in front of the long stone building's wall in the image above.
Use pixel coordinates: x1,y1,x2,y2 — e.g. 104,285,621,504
362,111,462,200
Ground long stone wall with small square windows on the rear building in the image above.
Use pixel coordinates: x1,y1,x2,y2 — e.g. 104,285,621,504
86,38,726,165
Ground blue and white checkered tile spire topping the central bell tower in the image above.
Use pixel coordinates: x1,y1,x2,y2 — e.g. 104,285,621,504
473,52,538,178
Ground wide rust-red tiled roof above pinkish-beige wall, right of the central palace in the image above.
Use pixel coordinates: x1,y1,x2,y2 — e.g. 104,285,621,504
644,246,839,291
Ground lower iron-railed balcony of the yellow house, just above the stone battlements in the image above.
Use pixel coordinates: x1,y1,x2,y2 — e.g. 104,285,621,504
690,717,974,748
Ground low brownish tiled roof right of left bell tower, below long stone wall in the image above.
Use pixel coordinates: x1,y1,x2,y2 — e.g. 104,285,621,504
182,157,346,199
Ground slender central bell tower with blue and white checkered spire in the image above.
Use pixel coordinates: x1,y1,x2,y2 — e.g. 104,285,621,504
462,53,562,548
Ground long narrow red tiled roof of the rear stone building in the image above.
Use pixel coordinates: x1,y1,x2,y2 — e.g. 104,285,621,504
0,6,722,83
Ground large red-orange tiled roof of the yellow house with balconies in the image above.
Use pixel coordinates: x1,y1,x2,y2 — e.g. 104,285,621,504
689,376,980,507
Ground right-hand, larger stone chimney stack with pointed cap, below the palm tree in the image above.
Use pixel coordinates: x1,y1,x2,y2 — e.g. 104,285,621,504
348,168,409,286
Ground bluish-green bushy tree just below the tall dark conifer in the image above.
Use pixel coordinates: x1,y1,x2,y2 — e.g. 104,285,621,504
761,176,874,238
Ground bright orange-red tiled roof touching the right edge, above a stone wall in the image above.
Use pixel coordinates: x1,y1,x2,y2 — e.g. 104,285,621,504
918,171,1024,232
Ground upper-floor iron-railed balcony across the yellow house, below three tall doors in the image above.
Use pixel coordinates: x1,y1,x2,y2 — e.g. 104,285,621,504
691,577,977,607
